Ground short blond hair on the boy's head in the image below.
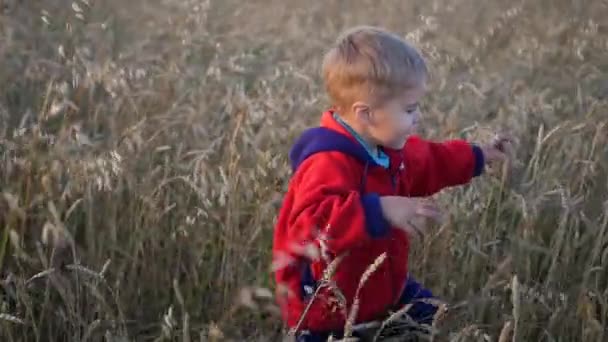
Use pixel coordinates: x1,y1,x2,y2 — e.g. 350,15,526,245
322,26,428,107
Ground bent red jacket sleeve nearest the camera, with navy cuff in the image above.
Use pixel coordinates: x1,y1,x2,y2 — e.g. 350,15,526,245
288,152,390,255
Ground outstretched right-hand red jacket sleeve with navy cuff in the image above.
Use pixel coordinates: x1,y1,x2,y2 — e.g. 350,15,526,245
402,137,485,196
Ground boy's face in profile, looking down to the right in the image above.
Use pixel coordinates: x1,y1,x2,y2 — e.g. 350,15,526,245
358,82,426,149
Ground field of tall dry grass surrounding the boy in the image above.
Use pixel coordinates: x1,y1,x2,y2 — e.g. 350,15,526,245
0,0,608,342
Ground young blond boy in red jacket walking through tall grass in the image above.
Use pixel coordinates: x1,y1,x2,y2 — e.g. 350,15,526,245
273,27,504,341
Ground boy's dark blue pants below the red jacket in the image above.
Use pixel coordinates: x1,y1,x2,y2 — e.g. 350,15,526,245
296,276,437,342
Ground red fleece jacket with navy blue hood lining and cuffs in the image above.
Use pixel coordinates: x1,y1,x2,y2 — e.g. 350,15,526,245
273,112,484,331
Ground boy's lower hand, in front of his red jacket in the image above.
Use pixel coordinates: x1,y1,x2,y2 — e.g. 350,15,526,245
380,196,442,239
